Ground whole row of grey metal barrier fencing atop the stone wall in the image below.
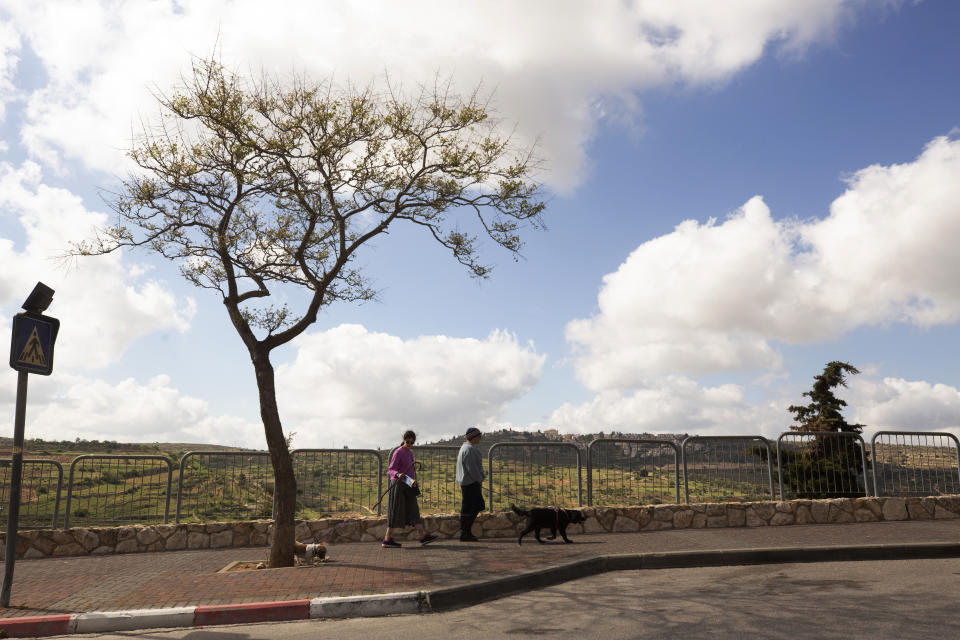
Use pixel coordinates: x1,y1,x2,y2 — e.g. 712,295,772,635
0,431,960,529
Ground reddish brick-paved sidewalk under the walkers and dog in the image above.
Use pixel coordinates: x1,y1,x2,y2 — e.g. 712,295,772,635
0,520,960,618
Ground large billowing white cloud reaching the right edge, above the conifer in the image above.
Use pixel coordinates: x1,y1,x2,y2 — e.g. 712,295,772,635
566,137,960,391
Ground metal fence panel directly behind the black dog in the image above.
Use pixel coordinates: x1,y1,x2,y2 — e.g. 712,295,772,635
487,442,583,511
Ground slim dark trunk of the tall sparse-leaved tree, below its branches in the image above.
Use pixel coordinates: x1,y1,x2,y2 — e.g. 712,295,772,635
253,350,297,567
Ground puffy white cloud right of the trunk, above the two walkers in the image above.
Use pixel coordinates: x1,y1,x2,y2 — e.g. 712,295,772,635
277,324,546,447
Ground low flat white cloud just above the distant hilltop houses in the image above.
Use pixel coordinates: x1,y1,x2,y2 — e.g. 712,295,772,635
532,376,790,437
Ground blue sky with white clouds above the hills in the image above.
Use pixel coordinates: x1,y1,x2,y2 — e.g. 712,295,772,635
0,0,960,448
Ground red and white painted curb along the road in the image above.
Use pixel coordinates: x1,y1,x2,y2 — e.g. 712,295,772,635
0,591,429,638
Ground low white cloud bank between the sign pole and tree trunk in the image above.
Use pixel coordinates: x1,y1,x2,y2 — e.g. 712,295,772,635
0,373,265,449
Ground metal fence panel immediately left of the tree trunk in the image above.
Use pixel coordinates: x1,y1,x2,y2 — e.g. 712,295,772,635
176,451,274,522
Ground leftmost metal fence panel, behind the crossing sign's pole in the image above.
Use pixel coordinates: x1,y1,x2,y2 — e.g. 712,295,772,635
0,458,63,531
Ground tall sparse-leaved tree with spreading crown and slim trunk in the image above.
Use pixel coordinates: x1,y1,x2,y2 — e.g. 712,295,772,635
74,59,544,567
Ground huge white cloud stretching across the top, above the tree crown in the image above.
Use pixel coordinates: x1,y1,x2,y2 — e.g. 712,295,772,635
0,0,859,188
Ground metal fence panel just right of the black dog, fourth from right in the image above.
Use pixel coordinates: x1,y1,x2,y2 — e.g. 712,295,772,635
587,438,680,506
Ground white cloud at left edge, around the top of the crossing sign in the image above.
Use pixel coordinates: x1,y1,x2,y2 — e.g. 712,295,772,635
0,162,194,370
